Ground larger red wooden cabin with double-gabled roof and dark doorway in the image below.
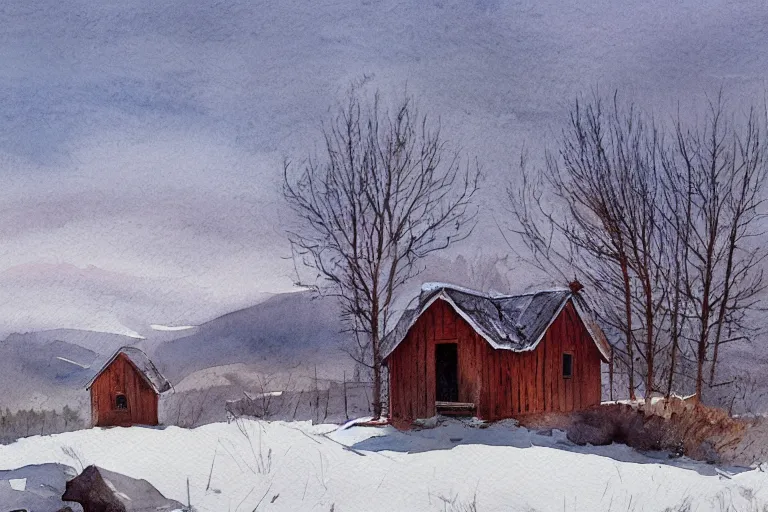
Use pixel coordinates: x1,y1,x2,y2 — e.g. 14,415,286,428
384,283,610,425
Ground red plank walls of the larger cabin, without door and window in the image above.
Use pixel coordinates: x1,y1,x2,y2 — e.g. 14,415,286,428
387,300,601,424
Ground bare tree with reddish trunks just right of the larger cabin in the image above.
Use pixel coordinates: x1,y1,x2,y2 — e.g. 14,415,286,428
509,96,664,398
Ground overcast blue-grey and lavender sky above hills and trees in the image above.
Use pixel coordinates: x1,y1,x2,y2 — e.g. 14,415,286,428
0,0,768,332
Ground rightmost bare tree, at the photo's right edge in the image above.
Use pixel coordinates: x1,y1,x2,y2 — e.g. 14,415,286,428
667,94,768,399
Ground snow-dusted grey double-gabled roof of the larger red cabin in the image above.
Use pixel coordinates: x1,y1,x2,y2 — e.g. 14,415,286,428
383,283,611,361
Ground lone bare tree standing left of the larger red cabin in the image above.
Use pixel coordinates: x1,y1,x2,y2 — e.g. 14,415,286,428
283,89,480,417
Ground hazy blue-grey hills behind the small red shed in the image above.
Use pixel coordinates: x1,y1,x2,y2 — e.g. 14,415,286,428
0,292,354,410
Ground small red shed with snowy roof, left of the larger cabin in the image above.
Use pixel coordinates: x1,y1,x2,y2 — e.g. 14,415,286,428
85,347,171,427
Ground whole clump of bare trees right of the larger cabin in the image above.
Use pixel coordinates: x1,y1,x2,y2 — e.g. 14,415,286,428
510,91,768,404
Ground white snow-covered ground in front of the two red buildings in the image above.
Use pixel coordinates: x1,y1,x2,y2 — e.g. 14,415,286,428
0,420,768,512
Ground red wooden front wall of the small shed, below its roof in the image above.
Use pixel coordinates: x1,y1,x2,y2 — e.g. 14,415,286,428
91,354,158,427
